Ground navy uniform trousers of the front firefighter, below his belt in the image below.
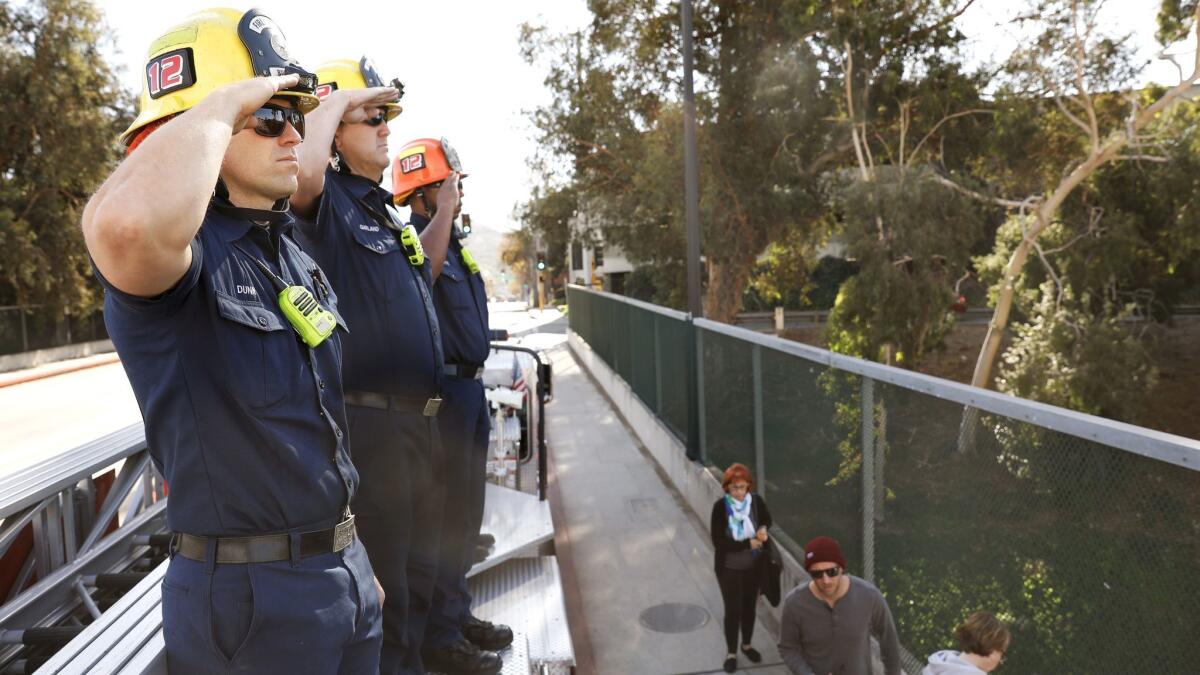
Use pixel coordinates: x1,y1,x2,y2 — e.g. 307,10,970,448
162,539,383,675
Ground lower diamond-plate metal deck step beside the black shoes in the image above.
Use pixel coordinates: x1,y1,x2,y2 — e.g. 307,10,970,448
468,556,575,674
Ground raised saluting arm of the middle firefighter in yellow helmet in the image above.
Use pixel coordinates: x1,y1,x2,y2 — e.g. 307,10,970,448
292,86,400,219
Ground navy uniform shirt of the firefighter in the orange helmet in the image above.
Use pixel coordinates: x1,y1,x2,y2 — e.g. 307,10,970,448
409,213,491,365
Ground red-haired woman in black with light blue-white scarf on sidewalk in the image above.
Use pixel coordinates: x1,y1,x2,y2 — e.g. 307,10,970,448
712,464,772,673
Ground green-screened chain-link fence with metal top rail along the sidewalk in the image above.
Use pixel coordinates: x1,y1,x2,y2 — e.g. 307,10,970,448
569,282,1200,673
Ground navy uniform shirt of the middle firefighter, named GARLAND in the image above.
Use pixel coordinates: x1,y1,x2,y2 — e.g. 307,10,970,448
296,169,443,399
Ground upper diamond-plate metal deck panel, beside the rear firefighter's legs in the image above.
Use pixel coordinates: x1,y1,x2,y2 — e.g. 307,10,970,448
467,483,554,578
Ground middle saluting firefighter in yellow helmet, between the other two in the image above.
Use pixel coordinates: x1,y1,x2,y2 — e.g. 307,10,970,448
292,58,500,674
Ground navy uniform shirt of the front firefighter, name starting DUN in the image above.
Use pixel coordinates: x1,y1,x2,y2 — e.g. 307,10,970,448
96,207,359,536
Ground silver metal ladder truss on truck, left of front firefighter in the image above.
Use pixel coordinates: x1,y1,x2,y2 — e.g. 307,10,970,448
0,423,167,667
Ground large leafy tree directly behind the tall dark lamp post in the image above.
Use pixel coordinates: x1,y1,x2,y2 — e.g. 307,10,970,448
523,0,833,319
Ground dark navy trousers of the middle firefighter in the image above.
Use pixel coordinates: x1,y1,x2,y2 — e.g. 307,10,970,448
346,405,445,675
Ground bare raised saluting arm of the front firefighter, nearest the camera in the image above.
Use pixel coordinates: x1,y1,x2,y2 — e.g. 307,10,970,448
83,74,299,297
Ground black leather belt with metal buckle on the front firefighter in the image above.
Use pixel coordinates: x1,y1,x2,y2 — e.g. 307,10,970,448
174,515,354,565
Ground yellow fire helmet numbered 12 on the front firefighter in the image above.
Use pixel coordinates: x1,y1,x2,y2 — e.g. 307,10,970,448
121,8,320,145
